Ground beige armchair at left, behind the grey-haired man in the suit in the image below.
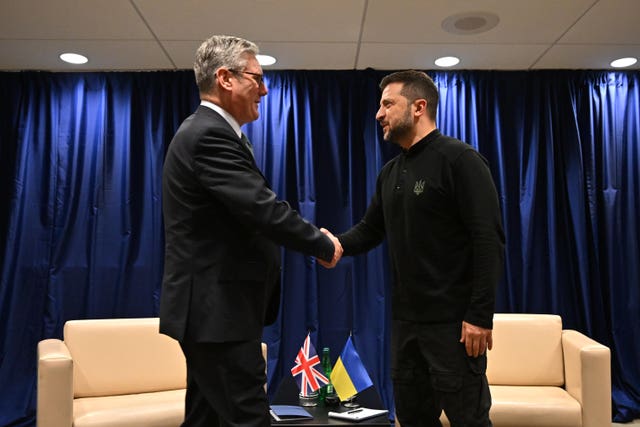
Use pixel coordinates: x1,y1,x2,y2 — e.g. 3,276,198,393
36,318,267,427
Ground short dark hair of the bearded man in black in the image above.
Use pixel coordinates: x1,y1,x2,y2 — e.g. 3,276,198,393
380,70,440,121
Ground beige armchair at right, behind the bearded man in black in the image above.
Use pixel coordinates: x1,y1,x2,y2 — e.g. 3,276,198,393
396,313,611,427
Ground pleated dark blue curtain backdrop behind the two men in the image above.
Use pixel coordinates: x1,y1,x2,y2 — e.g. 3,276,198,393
0,70,640,426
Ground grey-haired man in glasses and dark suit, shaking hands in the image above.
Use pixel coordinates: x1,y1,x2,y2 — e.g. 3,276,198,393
160,36,342,427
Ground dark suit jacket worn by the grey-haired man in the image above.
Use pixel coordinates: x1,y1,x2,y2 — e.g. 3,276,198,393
160,105,334,342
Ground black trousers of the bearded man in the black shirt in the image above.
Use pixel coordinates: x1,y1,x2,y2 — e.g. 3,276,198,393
391,320,492,427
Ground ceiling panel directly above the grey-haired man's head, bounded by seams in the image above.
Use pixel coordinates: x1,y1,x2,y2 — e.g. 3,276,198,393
135,0,365,42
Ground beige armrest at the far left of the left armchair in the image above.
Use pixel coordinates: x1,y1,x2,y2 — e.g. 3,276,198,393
36,339,73,427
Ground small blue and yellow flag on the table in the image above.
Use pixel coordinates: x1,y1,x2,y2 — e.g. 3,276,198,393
331,337,373,400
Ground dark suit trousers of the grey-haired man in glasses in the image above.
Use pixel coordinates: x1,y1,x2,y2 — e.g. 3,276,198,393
180,339,271,427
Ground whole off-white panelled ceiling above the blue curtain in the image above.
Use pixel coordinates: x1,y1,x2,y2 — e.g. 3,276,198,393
0,0,640,71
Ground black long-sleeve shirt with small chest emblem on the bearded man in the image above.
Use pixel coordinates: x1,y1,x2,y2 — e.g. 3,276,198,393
338,129,504,328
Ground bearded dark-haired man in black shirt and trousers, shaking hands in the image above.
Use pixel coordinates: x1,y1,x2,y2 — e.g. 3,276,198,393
324,71,504,427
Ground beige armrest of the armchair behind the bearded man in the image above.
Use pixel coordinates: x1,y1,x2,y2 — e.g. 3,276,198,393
562,329,611,427
